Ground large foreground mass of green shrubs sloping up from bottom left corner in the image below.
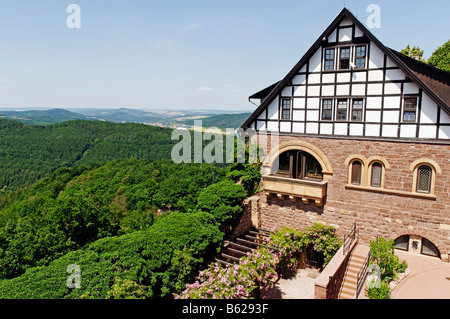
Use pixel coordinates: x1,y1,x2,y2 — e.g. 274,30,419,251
0,212,223,299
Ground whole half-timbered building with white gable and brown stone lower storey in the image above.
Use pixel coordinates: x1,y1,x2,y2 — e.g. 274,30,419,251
242,9,450,259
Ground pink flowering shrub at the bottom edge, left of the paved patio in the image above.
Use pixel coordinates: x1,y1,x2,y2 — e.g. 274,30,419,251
179,248,278,299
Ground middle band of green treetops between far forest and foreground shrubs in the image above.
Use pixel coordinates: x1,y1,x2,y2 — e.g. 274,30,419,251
0,159,227,278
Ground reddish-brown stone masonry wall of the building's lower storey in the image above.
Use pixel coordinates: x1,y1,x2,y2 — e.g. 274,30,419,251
255,136,450,259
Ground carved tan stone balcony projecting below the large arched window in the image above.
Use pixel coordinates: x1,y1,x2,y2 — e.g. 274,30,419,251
262,175,327,206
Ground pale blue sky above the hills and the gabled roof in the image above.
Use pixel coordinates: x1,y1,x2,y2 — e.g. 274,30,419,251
0,0,450,111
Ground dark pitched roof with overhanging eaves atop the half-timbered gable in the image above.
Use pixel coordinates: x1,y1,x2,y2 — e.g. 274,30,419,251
241,8,450,129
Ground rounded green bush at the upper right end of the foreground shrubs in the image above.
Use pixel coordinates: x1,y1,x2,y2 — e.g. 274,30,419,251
197,180,246,224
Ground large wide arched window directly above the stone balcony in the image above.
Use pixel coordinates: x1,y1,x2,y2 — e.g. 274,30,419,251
272,150,323,180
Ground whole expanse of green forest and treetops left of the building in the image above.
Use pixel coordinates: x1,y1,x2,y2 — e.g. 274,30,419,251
0,120,260,299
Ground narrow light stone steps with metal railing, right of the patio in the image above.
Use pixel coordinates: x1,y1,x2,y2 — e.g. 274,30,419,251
339,244,369,299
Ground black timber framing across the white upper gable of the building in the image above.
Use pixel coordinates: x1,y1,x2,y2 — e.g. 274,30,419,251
242,9,450,143
